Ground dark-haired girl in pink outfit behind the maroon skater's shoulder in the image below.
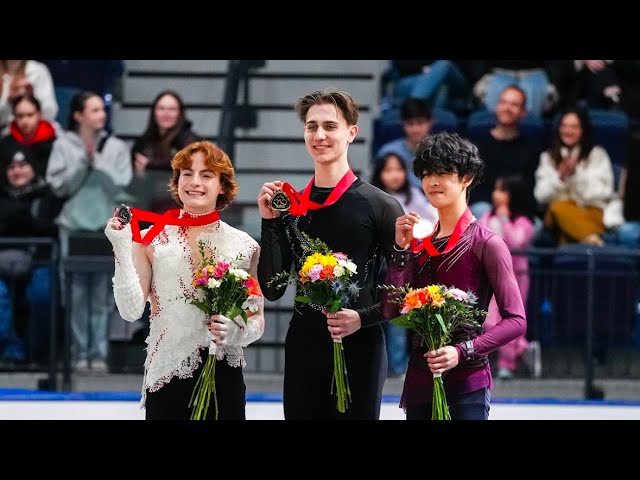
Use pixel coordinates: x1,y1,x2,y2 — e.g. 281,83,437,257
478,176,540,380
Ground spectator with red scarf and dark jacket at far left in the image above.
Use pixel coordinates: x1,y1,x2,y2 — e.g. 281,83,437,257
0,94,56,177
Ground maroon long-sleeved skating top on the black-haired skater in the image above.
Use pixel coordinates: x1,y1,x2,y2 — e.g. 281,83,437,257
382,221,527,407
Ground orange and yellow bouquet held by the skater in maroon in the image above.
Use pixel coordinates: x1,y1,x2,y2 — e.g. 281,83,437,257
381,285,487,420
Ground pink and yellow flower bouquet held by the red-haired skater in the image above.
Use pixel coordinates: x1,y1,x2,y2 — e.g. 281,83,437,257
187,241,262,420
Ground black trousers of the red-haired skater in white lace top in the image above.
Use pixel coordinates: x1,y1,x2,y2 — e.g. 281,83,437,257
145,349,246,420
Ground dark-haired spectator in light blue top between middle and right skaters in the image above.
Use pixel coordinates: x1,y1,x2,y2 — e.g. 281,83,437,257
375,98,433,191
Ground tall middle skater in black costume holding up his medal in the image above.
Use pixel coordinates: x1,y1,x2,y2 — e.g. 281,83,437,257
258,90,403,420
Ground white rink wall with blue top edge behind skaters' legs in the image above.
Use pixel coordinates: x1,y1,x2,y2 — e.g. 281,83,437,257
0,389,640,420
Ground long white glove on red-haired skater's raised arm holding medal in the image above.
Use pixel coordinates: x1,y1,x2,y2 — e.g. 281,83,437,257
104,223,147,322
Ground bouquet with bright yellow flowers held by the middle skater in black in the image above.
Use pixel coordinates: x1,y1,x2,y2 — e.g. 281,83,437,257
269,232,360,413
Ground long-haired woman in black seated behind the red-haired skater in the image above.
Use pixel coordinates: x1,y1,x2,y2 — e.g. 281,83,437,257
130,90,200,213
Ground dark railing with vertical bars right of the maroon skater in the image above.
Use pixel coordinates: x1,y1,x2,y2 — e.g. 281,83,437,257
512,244,640,399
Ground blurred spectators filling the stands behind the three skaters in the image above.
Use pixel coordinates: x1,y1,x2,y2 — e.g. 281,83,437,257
0,60,640,400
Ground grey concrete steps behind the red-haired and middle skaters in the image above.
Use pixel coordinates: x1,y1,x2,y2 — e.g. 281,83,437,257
113,60,387,238
